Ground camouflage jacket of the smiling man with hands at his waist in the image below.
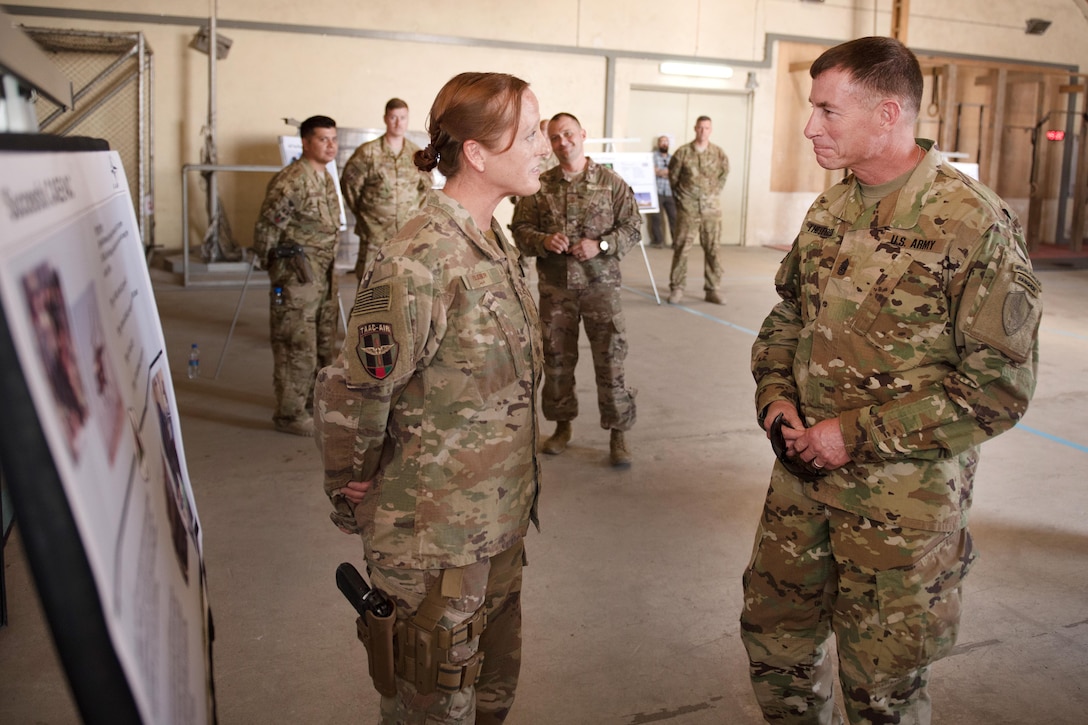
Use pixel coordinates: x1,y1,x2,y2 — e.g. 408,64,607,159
510,159,642,290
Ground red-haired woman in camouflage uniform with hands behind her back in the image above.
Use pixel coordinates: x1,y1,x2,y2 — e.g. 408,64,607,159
317,73,547,725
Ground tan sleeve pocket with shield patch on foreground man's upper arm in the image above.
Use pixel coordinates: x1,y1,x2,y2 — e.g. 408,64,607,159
972,265,1042,363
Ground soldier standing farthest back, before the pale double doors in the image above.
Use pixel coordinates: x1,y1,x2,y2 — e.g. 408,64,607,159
669,115,729,305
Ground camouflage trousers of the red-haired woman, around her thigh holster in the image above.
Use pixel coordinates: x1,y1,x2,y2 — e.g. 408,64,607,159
369,539,526,725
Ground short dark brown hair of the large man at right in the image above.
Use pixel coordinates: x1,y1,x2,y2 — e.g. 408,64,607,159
808,36,923,116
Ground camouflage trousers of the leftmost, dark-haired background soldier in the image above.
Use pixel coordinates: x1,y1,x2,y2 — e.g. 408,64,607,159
269,259,339,423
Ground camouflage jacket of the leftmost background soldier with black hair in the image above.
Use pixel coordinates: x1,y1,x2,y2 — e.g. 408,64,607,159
254,157,339,270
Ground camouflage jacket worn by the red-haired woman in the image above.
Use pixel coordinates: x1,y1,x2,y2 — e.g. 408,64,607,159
314,192,542,569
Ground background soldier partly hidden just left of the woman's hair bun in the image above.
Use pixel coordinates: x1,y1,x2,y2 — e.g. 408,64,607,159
341,98,431,280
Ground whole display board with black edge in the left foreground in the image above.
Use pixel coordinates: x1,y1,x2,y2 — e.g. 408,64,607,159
0,137,214,725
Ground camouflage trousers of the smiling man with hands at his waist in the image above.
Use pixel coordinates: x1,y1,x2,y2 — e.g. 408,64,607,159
540,282,635,431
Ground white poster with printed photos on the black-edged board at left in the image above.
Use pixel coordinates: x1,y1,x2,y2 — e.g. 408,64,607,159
0,151,212,724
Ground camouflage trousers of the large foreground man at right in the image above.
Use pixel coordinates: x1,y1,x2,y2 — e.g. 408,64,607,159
741,463,976,725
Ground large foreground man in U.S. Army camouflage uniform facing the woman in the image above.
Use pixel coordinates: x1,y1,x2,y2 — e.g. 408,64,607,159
741,38,1041,724
